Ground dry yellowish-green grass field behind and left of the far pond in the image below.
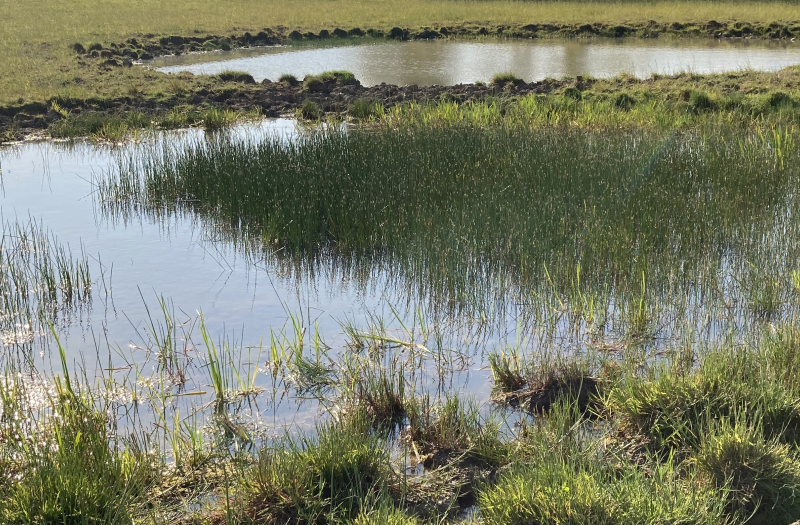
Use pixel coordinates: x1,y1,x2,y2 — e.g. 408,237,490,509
0,0,800,104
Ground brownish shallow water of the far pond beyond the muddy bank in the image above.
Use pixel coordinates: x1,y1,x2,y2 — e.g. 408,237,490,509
152,39,800,86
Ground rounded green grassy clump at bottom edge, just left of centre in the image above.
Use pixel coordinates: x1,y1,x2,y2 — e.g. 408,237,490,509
243,417,391,523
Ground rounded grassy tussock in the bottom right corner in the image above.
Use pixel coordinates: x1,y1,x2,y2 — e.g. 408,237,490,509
697,419,800,523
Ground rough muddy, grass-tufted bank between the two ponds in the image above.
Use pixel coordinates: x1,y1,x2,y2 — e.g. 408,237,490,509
0,67,800,141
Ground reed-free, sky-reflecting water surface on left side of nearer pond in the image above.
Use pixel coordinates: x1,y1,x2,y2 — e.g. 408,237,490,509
0,119,504,432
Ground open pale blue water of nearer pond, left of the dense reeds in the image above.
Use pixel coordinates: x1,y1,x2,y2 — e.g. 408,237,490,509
0,120,515,435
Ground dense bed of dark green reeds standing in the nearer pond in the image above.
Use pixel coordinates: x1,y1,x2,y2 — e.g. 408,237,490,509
99,124,798,348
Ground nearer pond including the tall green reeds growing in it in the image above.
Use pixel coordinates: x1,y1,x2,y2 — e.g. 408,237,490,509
0,105,800,442
